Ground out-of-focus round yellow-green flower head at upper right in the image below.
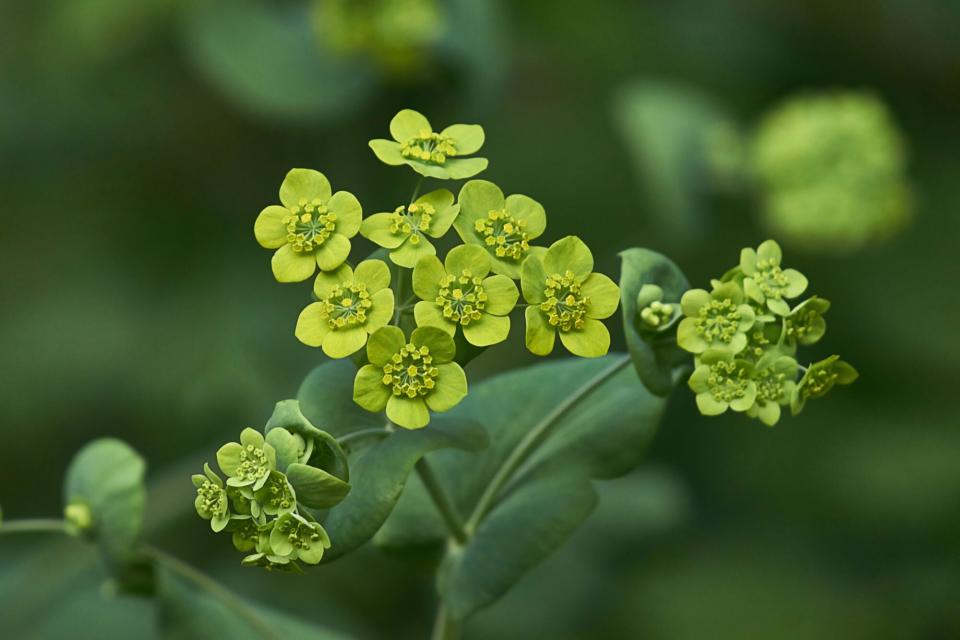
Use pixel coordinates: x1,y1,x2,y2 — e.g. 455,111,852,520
751,91,911,252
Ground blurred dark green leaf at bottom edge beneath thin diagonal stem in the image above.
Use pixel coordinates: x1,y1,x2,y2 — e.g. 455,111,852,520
157,564,348,640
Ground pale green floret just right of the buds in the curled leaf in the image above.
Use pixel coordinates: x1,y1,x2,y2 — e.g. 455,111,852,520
677,282,755,353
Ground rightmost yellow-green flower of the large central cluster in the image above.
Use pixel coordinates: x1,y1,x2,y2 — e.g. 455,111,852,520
520,236,620,358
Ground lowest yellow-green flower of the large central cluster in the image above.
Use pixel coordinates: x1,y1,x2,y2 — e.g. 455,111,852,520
353,325,467,429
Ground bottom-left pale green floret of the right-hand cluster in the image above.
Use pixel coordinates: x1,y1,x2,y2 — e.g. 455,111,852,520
688,349,757,416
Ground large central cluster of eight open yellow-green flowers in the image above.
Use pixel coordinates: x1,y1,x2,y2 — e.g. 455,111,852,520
254,109,620,429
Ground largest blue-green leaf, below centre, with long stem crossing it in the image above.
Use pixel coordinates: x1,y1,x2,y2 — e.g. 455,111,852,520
375,354,665,617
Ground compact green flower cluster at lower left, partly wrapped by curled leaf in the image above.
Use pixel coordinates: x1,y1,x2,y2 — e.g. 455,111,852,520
193,428,349,571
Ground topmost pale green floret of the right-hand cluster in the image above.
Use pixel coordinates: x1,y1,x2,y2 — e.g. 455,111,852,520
740,240,807,316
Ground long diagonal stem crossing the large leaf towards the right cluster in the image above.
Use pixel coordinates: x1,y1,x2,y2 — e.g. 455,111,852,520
467,354,630,533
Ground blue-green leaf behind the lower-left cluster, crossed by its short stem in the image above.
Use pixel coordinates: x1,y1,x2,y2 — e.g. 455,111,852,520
297,361,487,562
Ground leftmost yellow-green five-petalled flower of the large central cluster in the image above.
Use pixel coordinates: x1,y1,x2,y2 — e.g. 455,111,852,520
253,169,362,282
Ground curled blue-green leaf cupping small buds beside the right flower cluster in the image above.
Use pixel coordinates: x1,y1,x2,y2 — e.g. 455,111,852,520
620,248,690,396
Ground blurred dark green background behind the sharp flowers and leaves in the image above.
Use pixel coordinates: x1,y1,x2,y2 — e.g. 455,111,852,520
0,0,960,640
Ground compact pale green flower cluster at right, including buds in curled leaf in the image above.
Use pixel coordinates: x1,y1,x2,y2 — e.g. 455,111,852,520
676,240,857,426
